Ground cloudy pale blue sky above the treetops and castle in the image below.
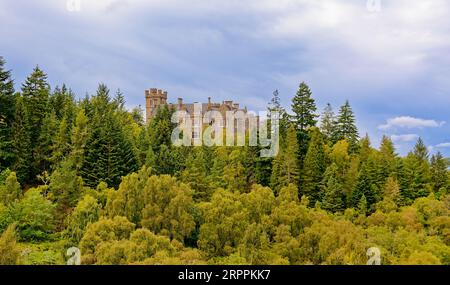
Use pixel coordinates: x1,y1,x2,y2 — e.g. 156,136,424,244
0,0,450,156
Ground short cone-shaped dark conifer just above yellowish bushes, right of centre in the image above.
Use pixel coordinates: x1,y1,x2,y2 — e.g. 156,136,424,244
322,163,345,213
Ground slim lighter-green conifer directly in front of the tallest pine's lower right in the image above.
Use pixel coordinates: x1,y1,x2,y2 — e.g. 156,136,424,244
300,128,326,205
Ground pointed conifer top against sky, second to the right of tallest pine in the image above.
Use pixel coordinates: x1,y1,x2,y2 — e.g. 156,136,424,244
334,101,359,153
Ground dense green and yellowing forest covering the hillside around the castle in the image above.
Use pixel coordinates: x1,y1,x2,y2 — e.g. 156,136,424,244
0,57,450,265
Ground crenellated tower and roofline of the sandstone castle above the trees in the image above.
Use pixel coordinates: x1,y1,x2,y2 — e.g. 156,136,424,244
145,88,247,122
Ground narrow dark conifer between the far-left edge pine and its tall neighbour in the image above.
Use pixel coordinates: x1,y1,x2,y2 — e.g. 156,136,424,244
12,96,32,183
